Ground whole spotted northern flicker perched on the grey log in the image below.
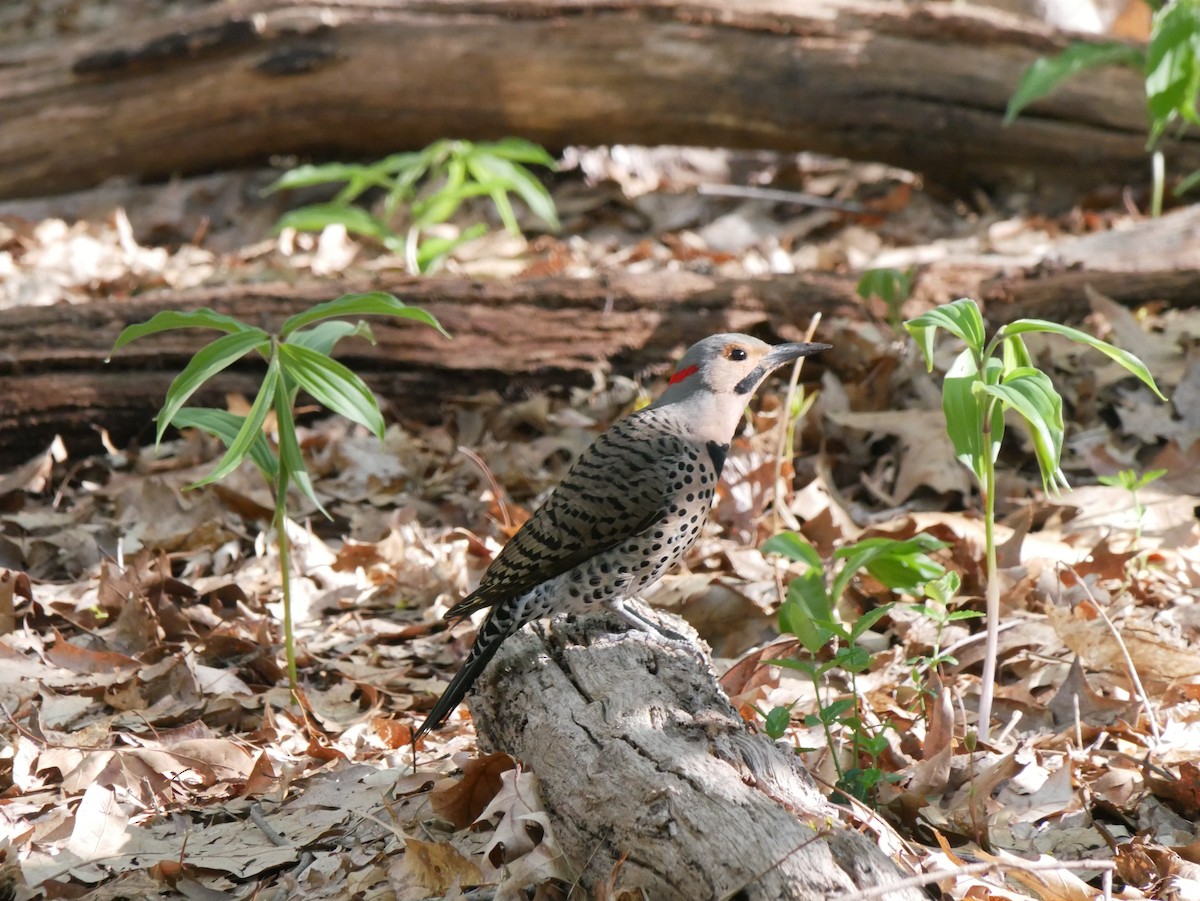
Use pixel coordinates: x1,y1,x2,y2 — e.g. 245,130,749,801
413,335,829,741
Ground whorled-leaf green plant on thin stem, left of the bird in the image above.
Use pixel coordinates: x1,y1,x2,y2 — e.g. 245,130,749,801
109,292,449,691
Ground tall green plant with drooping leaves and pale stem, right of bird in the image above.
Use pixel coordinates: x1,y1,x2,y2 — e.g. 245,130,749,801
905,298,1166,741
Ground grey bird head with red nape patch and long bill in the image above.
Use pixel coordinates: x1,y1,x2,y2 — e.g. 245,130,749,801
653,334,829,444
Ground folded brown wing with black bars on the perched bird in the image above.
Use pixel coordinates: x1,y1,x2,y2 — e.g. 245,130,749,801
446,422,684,619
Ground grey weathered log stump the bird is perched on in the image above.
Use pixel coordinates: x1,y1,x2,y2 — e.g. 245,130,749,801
470,614,924,901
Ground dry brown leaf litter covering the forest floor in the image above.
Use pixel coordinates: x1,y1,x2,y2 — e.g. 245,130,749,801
0,148,1200,901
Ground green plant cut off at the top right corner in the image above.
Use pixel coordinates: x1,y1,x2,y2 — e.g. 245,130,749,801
1004,0,1200,216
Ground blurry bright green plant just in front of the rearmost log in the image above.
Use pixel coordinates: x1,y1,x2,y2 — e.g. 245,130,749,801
266,138,559,274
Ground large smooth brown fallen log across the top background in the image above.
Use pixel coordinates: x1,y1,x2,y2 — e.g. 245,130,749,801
0,0,1200,197
